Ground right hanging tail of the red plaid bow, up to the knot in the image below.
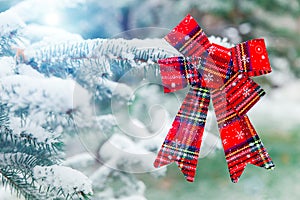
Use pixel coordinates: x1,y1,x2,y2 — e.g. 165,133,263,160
212,87,275,183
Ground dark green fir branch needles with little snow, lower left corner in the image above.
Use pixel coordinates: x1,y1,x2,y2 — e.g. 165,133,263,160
0,105,75,200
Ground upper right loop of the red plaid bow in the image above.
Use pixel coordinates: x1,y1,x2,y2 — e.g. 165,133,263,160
231,39,272,76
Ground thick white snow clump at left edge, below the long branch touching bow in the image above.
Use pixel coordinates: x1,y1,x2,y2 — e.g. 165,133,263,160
0,75,90,113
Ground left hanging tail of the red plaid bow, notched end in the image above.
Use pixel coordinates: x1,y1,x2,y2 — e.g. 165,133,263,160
154,87,210,182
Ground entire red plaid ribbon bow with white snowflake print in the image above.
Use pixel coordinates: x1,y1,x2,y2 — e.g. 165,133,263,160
154,15,274,183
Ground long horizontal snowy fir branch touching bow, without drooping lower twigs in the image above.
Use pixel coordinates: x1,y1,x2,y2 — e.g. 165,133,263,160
24,39,176,77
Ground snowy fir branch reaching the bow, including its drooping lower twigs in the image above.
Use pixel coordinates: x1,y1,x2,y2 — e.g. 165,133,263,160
24,39,178,100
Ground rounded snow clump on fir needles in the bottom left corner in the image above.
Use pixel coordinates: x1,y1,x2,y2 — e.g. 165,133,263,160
33,165,93,195
